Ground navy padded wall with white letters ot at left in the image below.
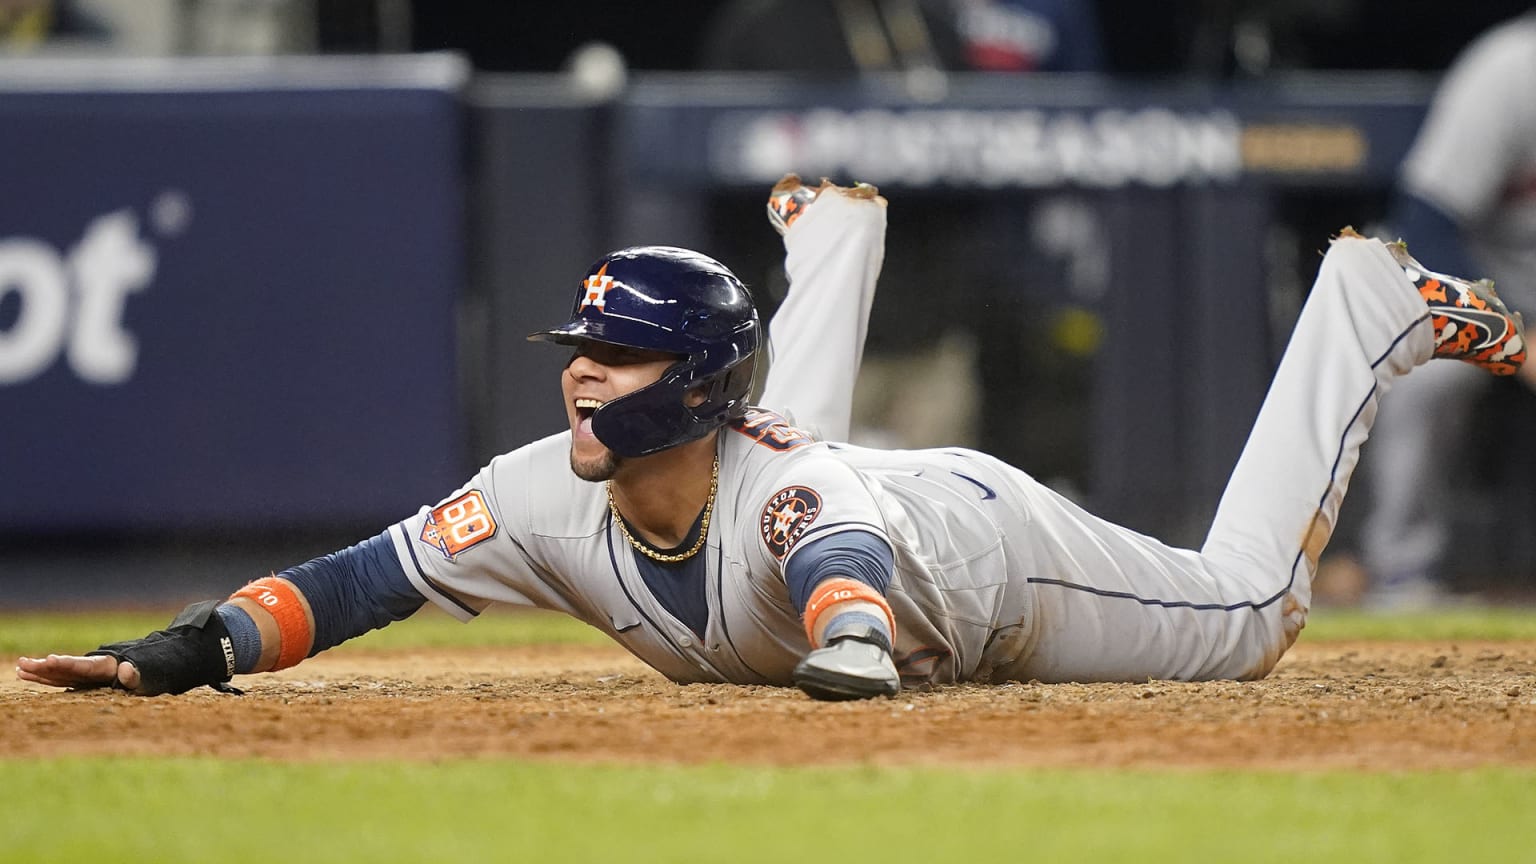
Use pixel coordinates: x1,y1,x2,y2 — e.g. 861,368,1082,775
0,57,465,533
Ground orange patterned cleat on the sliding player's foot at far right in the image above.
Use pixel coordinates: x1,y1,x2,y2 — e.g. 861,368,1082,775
1387,232,1525,375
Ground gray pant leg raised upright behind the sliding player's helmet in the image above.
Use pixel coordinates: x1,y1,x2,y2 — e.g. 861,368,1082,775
760,179,885,441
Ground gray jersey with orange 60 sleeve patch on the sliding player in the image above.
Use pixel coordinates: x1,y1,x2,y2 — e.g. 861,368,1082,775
390,412,1029,686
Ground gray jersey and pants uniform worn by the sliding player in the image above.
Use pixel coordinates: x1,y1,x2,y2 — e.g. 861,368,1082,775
389,203,1433,687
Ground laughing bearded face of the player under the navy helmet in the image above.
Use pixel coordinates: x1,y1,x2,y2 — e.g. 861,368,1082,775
561,341,677,483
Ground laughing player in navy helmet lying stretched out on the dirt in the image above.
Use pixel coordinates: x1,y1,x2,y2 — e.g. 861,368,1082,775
18,175,1525,700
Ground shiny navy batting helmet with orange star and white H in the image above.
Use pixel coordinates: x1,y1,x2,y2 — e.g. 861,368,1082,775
528,246,762,457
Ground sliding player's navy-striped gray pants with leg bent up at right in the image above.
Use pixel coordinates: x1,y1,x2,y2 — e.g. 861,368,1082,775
994,238,1433,681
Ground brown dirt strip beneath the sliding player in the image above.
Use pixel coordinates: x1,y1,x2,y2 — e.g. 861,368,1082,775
0,640,1536,770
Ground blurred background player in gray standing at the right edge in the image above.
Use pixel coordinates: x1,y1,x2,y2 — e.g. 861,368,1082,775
1361,12,1536,609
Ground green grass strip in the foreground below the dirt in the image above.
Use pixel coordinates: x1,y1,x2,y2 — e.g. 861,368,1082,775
0,759,1536,864
